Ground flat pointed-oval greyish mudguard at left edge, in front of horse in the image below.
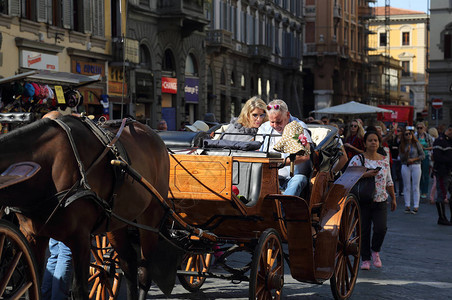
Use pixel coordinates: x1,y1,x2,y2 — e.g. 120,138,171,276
0,161,41,190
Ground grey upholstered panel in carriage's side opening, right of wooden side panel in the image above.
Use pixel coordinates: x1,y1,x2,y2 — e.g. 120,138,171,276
232,161,262,207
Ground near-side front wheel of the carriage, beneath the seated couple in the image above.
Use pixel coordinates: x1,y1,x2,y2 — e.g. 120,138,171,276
249,229,284,300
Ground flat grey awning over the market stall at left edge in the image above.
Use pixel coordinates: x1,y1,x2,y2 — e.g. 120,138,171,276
0,70,101,87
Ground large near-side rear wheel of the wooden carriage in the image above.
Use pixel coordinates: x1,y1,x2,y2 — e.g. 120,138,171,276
330,195,361,299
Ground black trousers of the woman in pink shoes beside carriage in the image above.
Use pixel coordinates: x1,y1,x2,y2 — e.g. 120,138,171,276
360,201,388,261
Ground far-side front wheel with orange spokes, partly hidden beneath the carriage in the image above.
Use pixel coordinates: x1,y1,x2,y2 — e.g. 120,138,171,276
177,253,213,293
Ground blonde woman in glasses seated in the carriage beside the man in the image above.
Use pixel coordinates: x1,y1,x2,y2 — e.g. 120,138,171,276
222,96,268,142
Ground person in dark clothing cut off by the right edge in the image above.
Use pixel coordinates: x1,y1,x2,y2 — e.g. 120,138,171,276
433,124,452,225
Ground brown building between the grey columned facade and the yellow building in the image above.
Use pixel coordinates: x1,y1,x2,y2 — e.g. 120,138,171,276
303,0,370,110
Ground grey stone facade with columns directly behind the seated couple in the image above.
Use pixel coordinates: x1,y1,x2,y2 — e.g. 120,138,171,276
206,0,307,122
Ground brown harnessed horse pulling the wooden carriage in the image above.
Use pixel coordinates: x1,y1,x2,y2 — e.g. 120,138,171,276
0,116,176,299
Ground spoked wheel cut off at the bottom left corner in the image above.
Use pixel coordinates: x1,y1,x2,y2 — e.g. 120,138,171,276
0,220,39,300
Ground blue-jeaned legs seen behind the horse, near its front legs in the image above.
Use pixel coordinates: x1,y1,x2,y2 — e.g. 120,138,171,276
41,239,73,300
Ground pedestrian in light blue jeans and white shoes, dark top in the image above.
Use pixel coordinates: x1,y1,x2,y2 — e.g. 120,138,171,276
399,126,425,214
